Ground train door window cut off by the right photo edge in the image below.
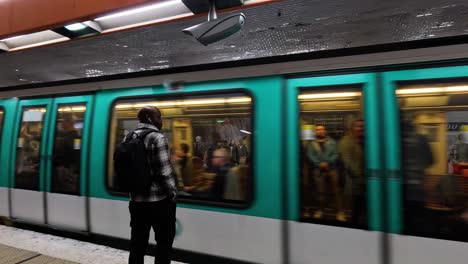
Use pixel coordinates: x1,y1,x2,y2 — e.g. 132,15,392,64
396,83,468,242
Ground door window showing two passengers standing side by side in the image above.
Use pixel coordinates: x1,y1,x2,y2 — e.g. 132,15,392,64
298,89,367,227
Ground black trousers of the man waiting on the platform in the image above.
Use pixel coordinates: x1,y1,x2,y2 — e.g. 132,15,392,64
128,199,176,264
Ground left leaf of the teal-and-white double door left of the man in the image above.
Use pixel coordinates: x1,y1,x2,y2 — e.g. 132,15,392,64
10,99,52,224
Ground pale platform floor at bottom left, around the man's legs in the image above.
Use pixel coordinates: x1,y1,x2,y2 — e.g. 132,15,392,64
0,225,183,264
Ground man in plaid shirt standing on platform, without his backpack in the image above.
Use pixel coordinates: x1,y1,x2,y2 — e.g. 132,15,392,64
124,106,177,264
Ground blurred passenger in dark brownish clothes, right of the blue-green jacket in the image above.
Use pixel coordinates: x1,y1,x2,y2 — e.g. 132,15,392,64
338,119,367,225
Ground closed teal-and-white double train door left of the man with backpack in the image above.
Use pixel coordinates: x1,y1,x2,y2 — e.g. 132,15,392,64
11,96,91,230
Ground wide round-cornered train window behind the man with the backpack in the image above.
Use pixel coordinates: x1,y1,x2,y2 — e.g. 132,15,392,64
107,93,252,204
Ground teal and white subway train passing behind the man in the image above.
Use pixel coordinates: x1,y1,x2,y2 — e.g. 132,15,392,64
0,44,468,264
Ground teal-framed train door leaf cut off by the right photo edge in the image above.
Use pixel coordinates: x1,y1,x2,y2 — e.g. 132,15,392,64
381,66,468,263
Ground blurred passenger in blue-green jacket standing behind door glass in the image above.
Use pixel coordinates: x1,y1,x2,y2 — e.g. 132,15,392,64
307,125,346,221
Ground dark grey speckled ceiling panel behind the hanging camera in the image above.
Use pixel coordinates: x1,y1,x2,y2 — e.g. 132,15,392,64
0,0,468,89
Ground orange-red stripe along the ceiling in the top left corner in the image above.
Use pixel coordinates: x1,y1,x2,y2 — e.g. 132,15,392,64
0,0,161,39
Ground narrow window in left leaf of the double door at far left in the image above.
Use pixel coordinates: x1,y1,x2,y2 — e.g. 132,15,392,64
15,106,46,191
